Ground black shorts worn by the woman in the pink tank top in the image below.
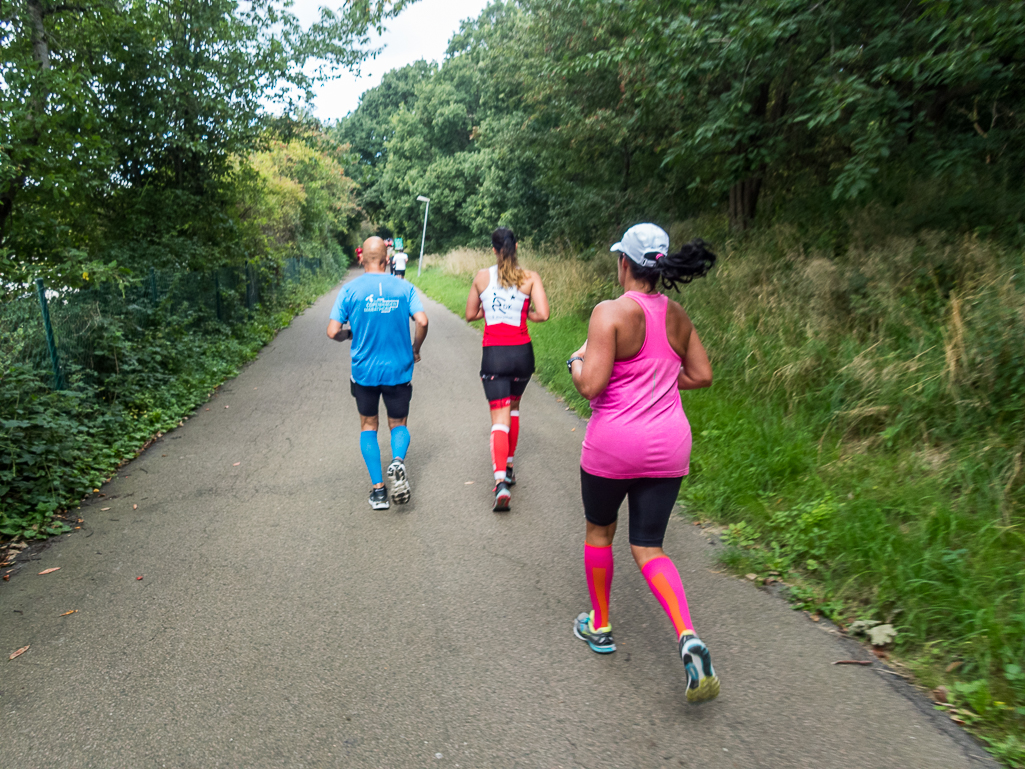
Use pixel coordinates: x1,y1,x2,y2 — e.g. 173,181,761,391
580,468,684,548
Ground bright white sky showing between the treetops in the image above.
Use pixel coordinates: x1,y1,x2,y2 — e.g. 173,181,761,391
291,0,488,120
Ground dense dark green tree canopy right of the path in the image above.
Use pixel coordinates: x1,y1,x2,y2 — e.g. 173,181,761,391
337,0,1025,246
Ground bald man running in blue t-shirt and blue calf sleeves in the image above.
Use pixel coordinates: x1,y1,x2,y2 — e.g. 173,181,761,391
327,238,427,510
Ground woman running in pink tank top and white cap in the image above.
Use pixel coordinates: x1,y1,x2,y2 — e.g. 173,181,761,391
567,224,720,702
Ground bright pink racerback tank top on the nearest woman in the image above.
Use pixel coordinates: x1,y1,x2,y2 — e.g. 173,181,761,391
580,291,691,478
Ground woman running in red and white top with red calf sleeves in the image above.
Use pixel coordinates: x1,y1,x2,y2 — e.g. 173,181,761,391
466,227,548,513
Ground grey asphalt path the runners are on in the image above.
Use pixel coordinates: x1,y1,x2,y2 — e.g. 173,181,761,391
0,274,995,769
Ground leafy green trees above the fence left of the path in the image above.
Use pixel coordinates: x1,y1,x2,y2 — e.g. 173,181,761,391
0,0,416,285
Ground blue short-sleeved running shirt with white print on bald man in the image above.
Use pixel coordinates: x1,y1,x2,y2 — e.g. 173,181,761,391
331,273,423,387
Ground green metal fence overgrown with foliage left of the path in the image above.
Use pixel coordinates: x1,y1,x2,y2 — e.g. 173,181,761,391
0,258,336,390
